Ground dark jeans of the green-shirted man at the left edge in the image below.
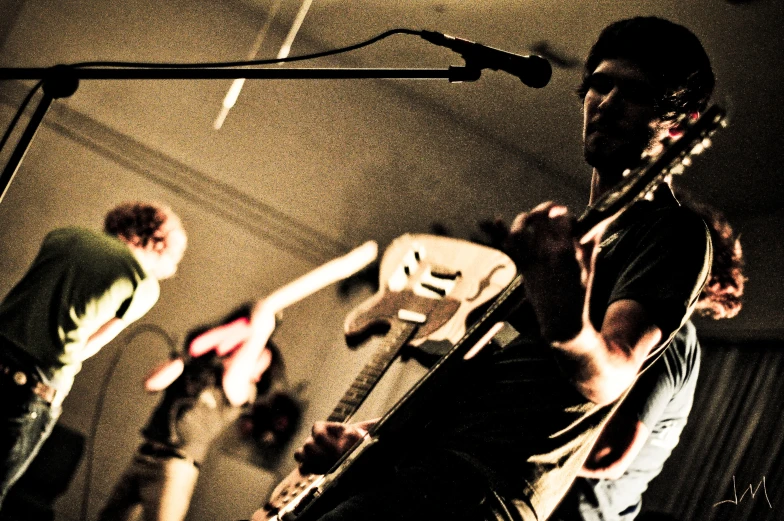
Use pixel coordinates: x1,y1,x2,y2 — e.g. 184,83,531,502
0,374,61,508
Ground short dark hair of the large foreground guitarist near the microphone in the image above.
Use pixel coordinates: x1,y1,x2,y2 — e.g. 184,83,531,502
577,16,716,120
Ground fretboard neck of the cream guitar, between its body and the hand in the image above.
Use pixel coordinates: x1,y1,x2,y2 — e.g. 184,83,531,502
327,320,417,423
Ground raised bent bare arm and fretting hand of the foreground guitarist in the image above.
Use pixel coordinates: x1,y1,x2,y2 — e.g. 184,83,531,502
508,203,662,405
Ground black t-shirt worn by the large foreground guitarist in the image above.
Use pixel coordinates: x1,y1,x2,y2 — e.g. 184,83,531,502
426,189,711,520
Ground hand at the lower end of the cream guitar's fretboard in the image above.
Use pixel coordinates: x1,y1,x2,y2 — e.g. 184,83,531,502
294,420,376,474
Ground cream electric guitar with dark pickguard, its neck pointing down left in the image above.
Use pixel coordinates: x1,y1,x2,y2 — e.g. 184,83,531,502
254,235,517,520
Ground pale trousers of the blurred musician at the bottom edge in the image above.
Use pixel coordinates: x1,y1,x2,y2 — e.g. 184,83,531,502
98,452,199,521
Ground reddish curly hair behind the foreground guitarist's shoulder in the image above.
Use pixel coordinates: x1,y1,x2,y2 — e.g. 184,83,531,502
687,202,746,320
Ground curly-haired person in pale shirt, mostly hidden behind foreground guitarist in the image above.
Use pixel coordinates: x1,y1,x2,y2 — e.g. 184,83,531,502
551,198,746,521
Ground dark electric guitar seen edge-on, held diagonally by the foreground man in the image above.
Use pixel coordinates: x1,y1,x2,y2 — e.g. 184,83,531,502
253,105,726,521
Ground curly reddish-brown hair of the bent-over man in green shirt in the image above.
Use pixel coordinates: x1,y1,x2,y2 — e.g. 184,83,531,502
103,202,172,247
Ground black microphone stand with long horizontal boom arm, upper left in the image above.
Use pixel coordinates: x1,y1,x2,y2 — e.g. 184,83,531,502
0,65,482,202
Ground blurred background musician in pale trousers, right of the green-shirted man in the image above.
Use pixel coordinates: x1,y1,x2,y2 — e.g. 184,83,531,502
98,304,284,521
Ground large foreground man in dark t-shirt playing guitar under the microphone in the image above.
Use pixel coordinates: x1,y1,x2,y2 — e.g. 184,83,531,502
296,17,714,521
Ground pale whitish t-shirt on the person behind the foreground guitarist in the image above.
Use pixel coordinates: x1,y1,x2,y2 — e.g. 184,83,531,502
555,322,700,521
